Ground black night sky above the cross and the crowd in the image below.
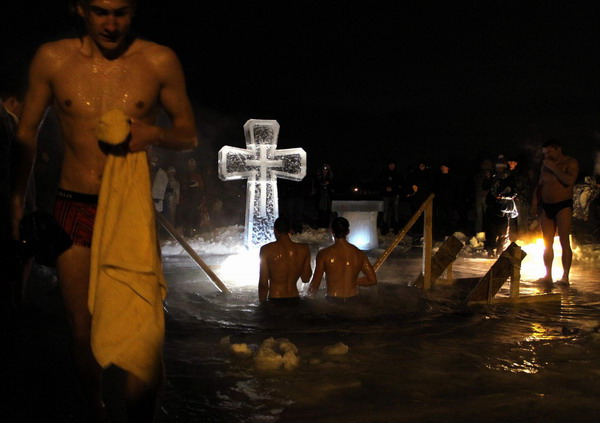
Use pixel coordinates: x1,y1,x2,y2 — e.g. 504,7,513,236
1,0,600,182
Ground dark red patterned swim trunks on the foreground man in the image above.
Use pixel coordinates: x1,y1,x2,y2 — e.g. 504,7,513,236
53,189,98,248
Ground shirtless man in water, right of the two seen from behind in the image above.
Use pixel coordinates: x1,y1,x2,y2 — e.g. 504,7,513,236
308,217,377,302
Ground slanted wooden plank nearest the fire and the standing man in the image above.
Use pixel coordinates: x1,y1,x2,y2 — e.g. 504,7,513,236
467,242,527,303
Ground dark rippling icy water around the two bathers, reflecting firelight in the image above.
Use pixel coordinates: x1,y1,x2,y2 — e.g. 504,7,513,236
159,248,600,422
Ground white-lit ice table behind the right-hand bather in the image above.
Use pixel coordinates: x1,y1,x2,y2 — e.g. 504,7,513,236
331,201,383,250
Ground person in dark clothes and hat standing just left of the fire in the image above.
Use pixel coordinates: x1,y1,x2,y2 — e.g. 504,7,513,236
482,155,517,258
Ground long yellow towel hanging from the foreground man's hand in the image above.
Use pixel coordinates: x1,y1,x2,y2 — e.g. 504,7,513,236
88,152,166,383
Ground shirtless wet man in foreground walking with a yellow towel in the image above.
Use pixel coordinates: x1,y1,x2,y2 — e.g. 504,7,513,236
10,0,197,422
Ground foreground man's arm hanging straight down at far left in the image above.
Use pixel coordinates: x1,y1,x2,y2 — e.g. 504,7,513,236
10,45,54,239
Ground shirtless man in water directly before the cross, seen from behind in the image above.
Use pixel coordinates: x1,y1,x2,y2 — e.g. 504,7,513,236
258,217,312,303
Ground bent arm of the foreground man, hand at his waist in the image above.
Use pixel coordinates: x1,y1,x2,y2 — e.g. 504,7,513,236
129,46,198,151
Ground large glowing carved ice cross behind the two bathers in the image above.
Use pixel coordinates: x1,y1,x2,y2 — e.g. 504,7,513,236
219,119,306,247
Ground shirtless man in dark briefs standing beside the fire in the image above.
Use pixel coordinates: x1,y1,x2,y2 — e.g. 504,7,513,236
531,140,579,284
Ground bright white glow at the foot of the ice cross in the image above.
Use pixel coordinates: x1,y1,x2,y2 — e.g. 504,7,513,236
215,248,260,287
